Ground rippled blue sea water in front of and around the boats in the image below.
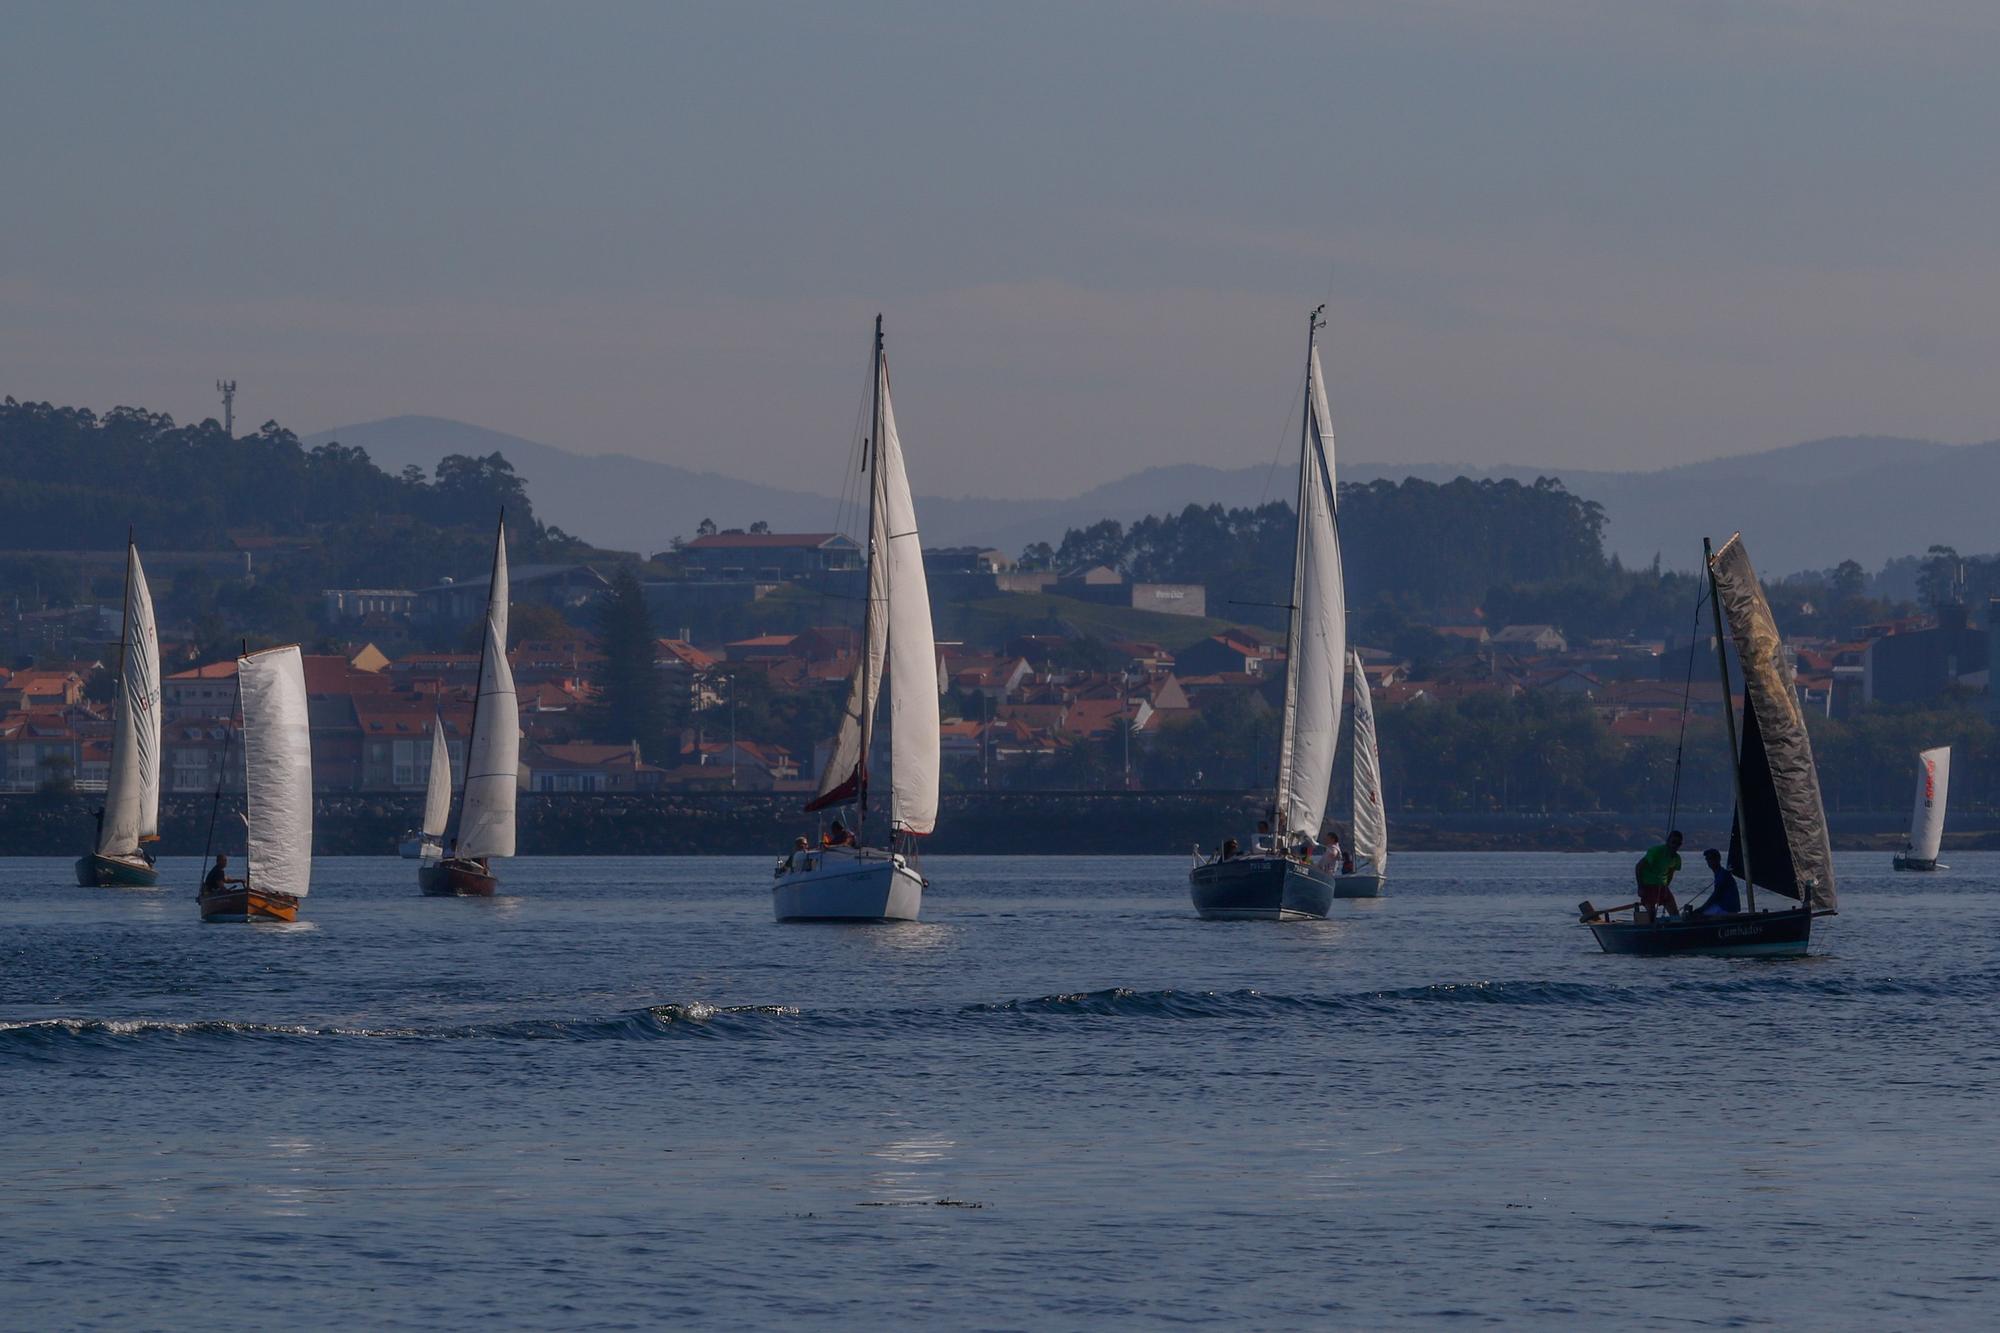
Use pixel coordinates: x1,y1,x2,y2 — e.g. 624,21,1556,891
0,855,2000,1329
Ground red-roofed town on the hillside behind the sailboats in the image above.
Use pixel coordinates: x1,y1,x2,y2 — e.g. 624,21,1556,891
0,524,2000,809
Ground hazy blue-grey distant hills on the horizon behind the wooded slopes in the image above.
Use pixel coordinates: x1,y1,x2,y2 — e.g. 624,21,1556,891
306,416,2000,574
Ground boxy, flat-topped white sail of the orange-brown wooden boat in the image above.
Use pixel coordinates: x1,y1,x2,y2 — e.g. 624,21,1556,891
236,644,312,899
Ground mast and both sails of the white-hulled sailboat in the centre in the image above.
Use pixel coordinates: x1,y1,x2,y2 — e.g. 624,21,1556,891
806,322,938,833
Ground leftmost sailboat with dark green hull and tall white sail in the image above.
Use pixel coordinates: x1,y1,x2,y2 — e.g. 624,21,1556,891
76,534,160,889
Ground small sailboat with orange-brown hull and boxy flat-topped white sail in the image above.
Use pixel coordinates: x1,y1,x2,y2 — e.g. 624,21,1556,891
198,644,312,921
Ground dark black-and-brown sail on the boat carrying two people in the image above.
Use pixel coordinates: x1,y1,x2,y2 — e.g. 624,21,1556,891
1708,534,1838,911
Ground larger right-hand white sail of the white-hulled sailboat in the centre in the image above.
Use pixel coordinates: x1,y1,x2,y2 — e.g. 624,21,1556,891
876,358,938,833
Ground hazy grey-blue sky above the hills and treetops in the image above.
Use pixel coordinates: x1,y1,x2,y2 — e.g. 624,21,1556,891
0,0,2000,494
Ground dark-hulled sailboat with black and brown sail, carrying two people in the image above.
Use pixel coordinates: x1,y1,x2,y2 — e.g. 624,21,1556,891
1580,532,1838,959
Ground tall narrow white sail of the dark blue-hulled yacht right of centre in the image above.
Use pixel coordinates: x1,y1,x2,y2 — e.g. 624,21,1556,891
1278,344,1348,835
